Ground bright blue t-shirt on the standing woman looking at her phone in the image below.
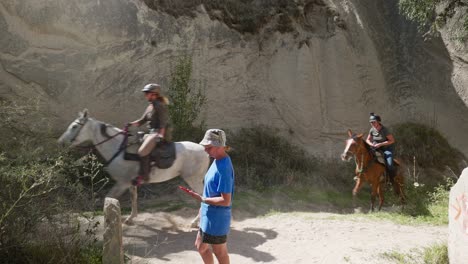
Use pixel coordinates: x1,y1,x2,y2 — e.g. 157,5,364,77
200,156,234,236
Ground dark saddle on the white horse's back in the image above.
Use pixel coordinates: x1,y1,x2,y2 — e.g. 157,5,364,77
124,141,176,169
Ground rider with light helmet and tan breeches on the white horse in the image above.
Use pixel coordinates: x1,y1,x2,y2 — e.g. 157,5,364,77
128,83,172,186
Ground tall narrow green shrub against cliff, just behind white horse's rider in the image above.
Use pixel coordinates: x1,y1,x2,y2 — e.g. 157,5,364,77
169,55,206,142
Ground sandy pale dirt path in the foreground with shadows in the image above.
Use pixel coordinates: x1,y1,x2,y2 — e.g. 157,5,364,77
123,209,448,264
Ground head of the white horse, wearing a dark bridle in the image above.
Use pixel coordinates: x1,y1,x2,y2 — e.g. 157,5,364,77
58,109,89,146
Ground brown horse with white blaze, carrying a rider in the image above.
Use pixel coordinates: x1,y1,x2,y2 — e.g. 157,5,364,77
341,130,405,211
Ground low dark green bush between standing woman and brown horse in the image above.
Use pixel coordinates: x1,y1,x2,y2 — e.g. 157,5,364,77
227,126,352,190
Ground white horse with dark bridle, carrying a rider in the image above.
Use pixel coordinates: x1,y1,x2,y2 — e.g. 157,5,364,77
58,109,209,226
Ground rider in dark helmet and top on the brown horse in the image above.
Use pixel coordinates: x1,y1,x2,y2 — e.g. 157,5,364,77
366,113,395,182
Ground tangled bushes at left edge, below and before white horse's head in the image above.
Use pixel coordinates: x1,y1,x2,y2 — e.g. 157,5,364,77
0,101,100,263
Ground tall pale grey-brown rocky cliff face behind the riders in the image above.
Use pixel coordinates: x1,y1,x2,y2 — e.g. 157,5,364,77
0,0,468,155
